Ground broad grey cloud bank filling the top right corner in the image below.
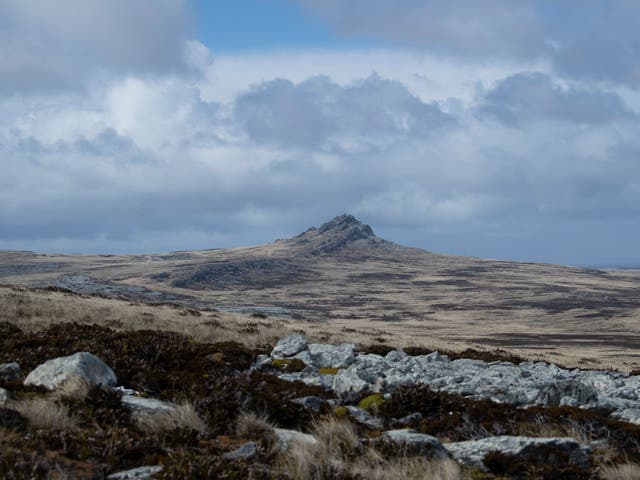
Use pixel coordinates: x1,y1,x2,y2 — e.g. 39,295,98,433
298,0,640,89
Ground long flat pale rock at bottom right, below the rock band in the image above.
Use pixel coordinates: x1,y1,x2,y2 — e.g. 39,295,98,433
444,435,591,467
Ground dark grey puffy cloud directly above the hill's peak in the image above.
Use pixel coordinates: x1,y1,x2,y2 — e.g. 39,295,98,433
235,74,453,148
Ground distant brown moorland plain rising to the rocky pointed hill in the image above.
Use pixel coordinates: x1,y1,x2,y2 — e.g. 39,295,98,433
0,215,640,370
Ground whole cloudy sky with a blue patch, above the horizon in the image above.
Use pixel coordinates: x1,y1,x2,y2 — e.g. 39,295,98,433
0,0,640,266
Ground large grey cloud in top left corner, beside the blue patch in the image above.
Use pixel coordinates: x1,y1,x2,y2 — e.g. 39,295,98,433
0,0,188,93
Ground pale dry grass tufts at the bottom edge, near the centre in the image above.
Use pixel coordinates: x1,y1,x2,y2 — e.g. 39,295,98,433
280,418,461,480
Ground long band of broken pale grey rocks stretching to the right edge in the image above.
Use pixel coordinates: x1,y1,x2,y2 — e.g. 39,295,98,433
255,335,640,424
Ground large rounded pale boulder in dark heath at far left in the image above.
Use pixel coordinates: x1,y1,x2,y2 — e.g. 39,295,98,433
24,352,117,390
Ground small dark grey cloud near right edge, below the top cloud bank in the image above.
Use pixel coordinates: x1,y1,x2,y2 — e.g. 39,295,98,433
479,73,635,126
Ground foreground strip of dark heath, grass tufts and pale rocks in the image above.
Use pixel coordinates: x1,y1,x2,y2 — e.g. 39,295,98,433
0,323,640,479
